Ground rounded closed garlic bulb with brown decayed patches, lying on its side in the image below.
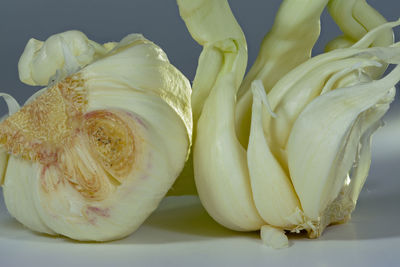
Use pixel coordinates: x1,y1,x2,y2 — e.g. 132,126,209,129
0,31,192,241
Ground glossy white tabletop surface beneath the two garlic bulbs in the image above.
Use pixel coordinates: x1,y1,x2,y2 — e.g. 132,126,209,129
0,111,400,267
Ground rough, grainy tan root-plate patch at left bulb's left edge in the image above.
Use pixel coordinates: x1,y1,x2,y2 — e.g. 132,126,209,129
0,74,87,165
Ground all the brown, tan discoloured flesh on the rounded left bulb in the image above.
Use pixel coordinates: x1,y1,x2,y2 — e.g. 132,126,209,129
0,73,135,202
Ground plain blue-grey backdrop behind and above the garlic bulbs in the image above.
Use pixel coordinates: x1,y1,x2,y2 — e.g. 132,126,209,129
0,0,400,114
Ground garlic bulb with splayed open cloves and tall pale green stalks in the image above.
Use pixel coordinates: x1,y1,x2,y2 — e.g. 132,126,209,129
178,0,400,248
